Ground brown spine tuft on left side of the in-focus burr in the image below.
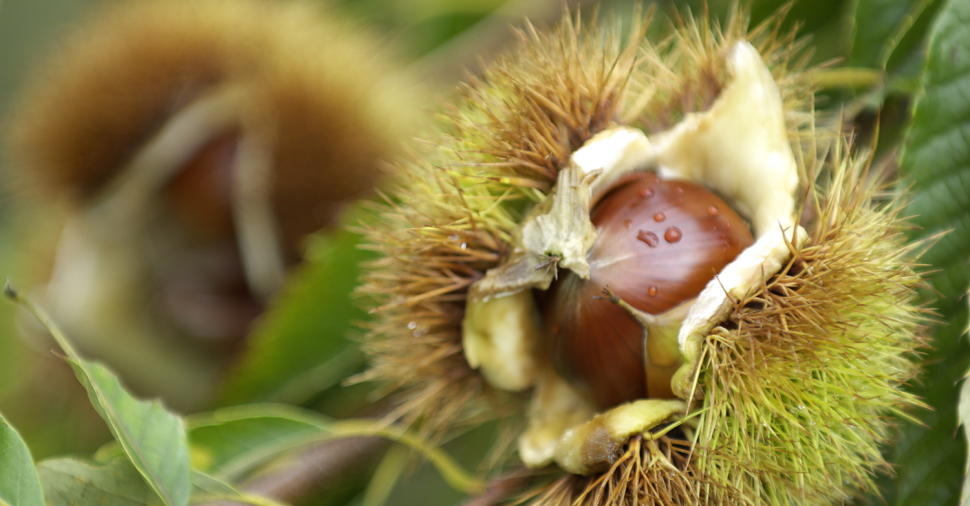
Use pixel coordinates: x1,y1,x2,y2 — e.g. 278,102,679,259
361,215,499,432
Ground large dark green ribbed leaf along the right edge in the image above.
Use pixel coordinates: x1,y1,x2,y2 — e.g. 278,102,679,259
883,0,970,505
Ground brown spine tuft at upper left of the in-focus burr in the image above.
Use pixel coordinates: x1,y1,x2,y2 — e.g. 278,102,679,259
450,15,645,196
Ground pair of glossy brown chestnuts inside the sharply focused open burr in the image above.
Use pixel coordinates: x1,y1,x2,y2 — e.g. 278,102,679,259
541,172,753,408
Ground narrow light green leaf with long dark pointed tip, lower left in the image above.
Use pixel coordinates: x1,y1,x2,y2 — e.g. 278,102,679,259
5,286,192,506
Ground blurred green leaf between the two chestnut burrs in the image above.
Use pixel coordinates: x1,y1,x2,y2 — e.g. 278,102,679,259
223,230,372,404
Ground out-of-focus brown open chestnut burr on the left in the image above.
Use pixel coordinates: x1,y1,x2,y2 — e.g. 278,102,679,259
9,0,416,405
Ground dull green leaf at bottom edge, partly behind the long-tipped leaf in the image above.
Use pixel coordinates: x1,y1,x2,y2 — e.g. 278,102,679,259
37,458,159,506
